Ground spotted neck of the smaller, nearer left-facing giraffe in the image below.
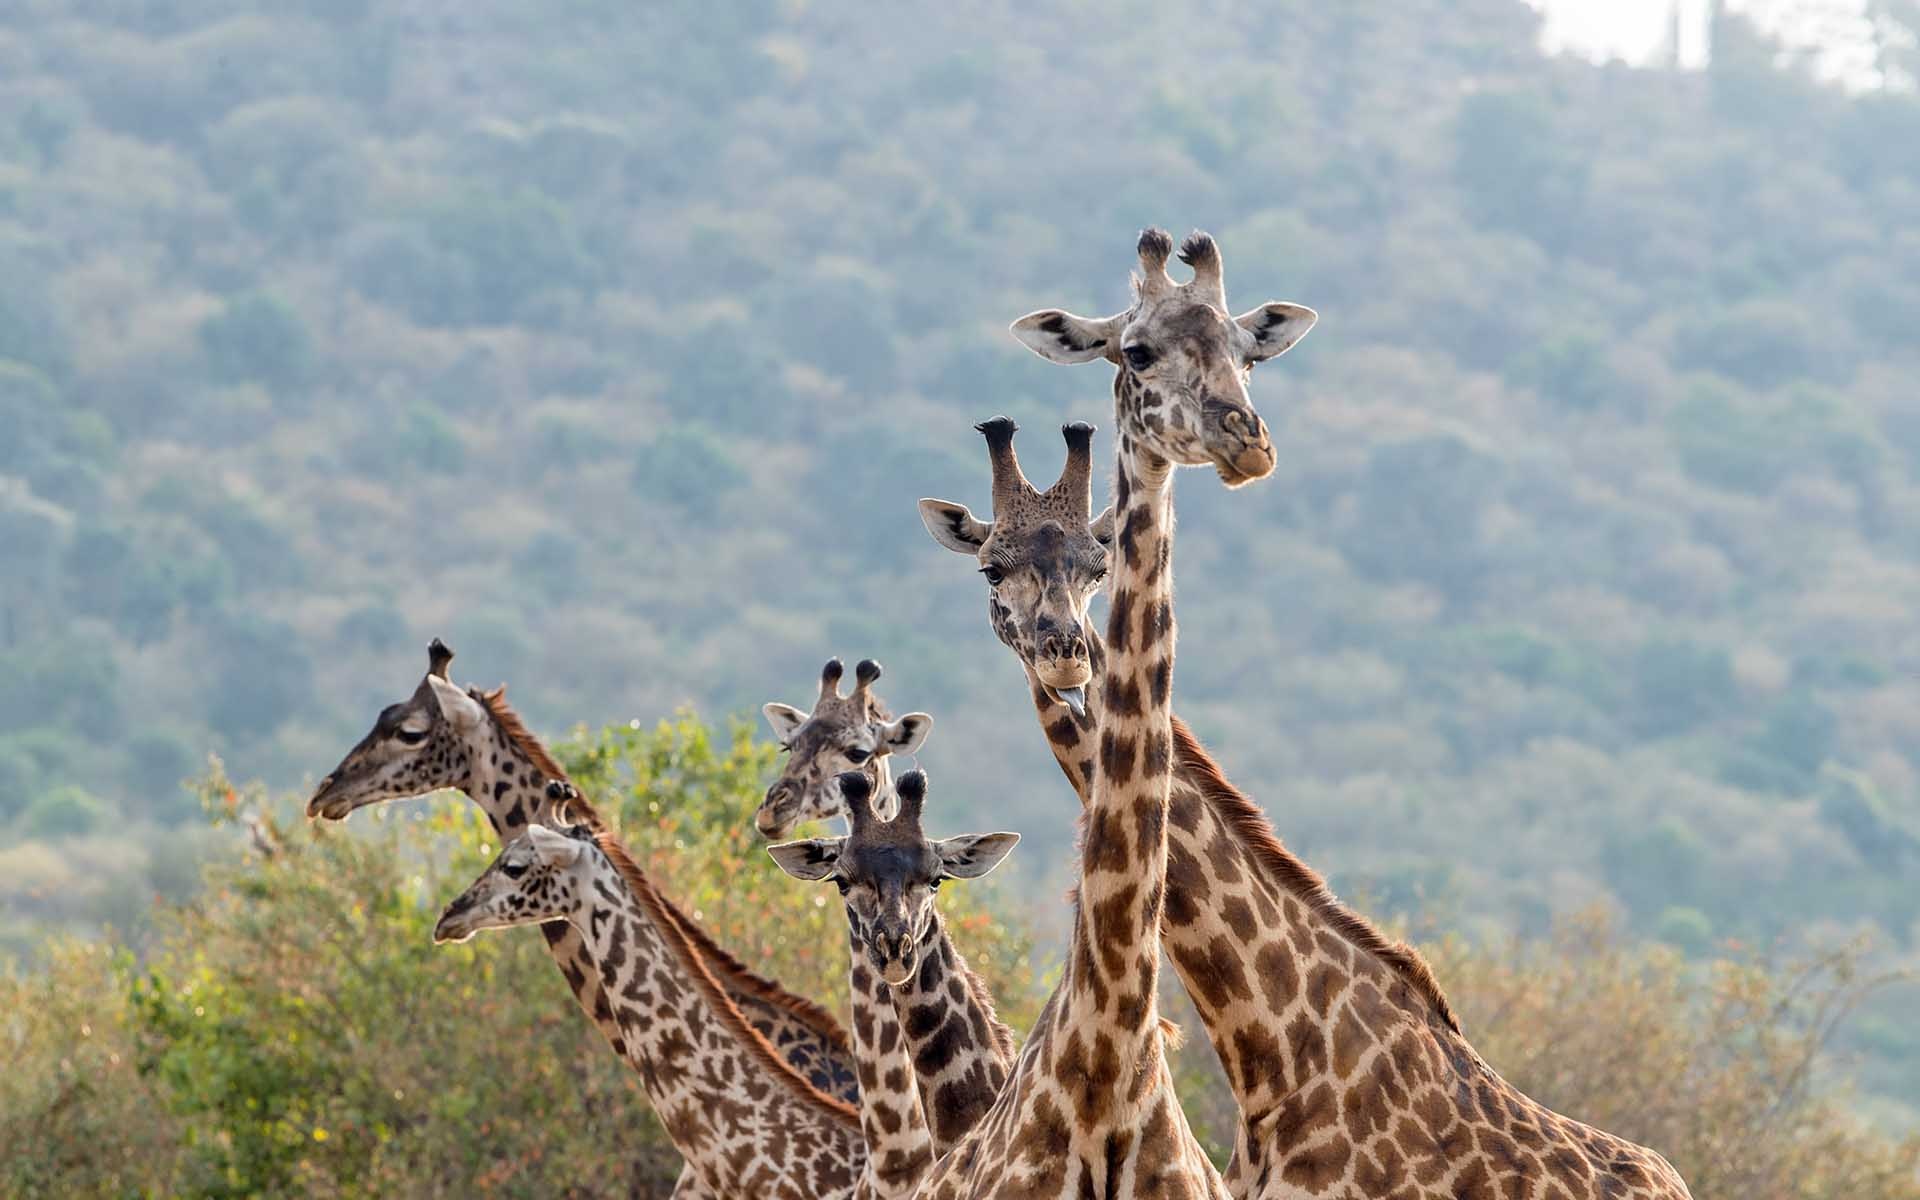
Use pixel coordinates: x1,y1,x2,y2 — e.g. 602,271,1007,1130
568,849,866,1198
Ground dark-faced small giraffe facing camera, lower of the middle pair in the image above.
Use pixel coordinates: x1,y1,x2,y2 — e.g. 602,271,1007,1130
768,770,1020,1156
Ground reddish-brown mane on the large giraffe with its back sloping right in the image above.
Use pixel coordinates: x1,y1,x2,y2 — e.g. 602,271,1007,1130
1173,716,1459,1033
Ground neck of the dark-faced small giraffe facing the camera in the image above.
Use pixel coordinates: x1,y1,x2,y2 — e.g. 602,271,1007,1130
893,912,1014,1154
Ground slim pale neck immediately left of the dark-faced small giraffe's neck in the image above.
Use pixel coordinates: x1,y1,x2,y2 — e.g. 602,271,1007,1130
847,929,935,1200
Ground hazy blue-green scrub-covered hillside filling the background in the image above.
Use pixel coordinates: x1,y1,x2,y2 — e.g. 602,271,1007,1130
0,0,1920,1182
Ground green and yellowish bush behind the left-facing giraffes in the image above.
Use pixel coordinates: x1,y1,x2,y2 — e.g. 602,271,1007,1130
0,716,1043,1196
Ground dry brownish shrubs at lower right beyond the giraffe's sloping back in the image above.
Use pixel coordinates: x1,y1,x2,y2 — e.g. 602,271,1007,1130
1434,914,1920,1200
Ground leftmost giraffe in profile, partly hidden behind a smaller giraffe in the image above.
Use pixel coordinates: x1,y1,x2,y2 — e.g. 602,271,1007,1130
307,637,858,1159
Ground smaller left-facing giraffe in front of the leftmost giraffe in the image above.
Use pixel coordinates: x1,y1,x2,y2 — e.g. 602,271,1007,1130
434,780,867,1200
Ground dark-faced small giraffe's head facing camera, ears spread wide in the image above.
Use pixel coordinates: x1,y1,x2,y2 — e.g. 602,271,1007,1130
766,770,1020,985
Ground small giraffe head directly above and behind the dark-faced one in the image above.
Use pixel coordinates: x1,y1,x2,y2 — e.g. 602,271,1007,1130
753,659,933,837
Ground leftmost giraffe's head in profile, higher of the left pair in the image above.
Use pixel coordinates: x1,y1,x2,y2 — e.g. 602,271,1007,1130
307,637,488,820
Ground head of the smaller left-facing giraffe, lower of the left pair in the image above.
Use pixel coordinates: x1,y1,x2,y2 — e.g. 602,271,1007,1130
434,781,593,945
